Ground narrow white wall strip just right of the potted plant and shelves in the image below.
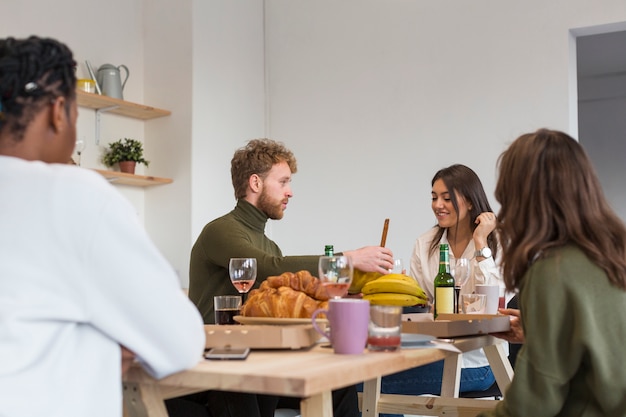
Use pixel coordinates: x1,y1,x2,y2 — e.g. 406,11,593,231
142,0,193,287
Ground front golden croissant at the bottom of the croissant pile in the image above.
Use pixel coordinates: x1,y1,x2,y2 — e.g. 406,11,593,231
241,285,328,318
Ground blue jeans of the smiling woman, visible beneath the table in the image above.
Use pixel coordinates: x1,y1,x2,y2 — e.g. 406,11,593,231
357,361,496,417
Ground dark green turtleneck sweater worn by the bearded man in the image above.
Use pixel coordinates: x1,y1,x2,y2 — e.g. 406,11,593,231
189,200,320,324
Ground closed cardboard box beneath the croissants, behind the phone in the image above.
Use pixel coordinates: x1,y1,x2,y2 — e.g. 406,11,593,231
204,324,321,349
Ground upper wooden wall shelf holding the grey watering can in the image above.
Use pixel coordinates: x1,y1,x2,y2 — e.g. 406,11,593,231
76,90,172,120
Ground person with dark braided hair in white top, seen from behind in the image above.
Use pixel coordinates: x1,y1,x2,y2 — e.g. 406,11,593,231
0,36,204,417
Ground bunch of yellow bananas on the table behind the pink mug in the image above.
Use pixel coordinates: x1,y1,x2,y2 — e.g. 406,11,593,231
361,274,428,307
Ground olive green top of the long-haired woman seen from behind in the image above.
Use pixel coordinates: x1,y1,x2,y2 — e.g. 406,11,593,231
480,246,626,417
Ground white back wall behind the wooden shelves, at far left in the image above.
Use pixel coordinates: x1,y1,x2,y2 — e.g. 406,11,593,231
0,0,144,196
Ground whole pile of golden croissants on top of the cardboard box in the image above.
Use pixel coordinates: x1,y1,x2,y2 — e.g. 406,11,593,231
241,271,329,318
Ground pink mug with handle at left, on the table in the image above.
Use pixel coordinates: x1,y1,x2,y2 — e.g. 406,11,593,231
311,298,370,354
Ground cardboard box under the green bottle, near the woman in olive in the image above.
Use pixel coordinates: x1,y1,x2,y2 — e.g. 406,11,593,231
402,314,511,337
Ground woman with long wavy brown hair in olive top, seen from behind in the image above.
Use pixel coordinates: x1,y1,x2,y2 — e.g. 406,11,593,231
484,129,626,417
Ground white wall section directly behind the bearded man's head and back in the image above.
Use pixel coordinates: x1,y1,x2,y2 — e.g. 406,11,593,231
190,0,266,240
